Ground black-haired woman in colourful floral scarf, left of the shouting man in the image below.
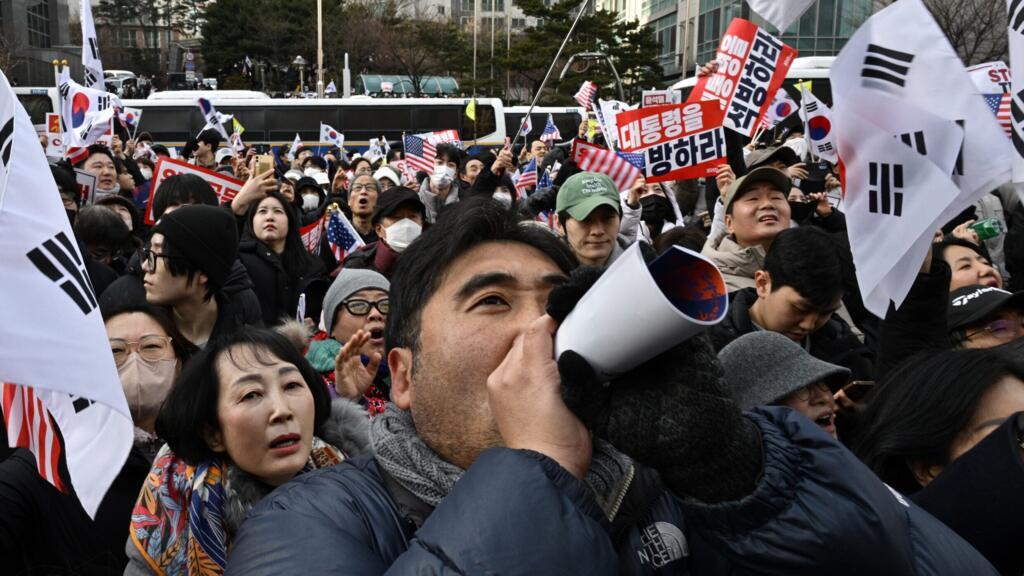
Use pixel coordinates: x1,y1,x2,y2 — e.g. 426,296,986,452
125,330,369,576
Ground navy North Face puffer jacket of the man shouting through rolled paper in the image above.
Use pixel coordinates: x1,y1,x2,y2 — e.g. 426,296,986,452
225,408,995,576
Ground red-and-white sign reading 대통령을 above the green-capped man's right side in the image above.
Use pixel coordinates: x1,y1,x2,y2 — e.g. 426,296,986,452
638,100,726,182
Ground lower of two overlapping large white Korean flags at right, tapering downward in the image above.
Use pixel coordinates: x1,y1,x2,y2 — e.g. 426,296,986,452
833,98,963,318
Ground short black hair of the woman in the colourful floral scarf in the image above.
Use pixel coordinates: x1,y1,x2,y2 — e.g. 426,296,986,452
157,328,331,465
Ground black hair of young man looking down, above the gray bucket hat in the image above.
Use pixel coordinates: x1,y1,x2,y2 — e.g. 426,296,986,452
764,227,843,308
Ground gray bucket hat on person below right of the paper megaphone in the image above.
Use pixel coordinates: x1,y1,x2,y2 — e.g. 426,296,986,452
718,330,850,410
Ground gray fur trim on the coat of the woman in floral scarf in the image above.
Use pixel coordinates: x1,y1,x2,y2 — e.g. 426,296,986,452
224,398,373,541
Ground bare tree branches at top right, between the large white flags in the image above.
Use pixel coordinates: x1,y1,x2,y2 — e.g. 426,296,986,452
876,0,1008,66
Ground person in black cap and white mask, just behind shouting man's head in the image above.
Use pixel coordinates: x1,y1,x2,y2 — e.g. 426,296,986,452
342,187,426,278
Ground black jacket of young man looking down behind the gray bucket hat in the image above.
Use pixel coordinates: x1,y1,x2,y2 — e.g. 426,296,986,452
710,288,874,380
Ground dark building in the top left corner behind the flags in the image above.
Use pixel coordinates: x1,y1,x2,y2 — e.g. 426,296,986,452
0,0,82,86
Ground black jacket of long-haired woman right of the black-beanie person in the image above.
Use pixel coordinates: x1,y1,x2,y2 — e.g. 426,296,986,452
239,240,331,326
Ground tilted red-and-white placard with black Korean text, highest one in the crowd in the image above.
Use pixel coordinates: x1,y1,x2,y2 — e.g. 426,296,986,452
687,18,797,136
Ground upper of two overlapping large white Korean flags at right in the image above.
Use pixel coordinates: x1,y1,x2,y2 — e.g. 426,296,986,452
829,0,1014,204
